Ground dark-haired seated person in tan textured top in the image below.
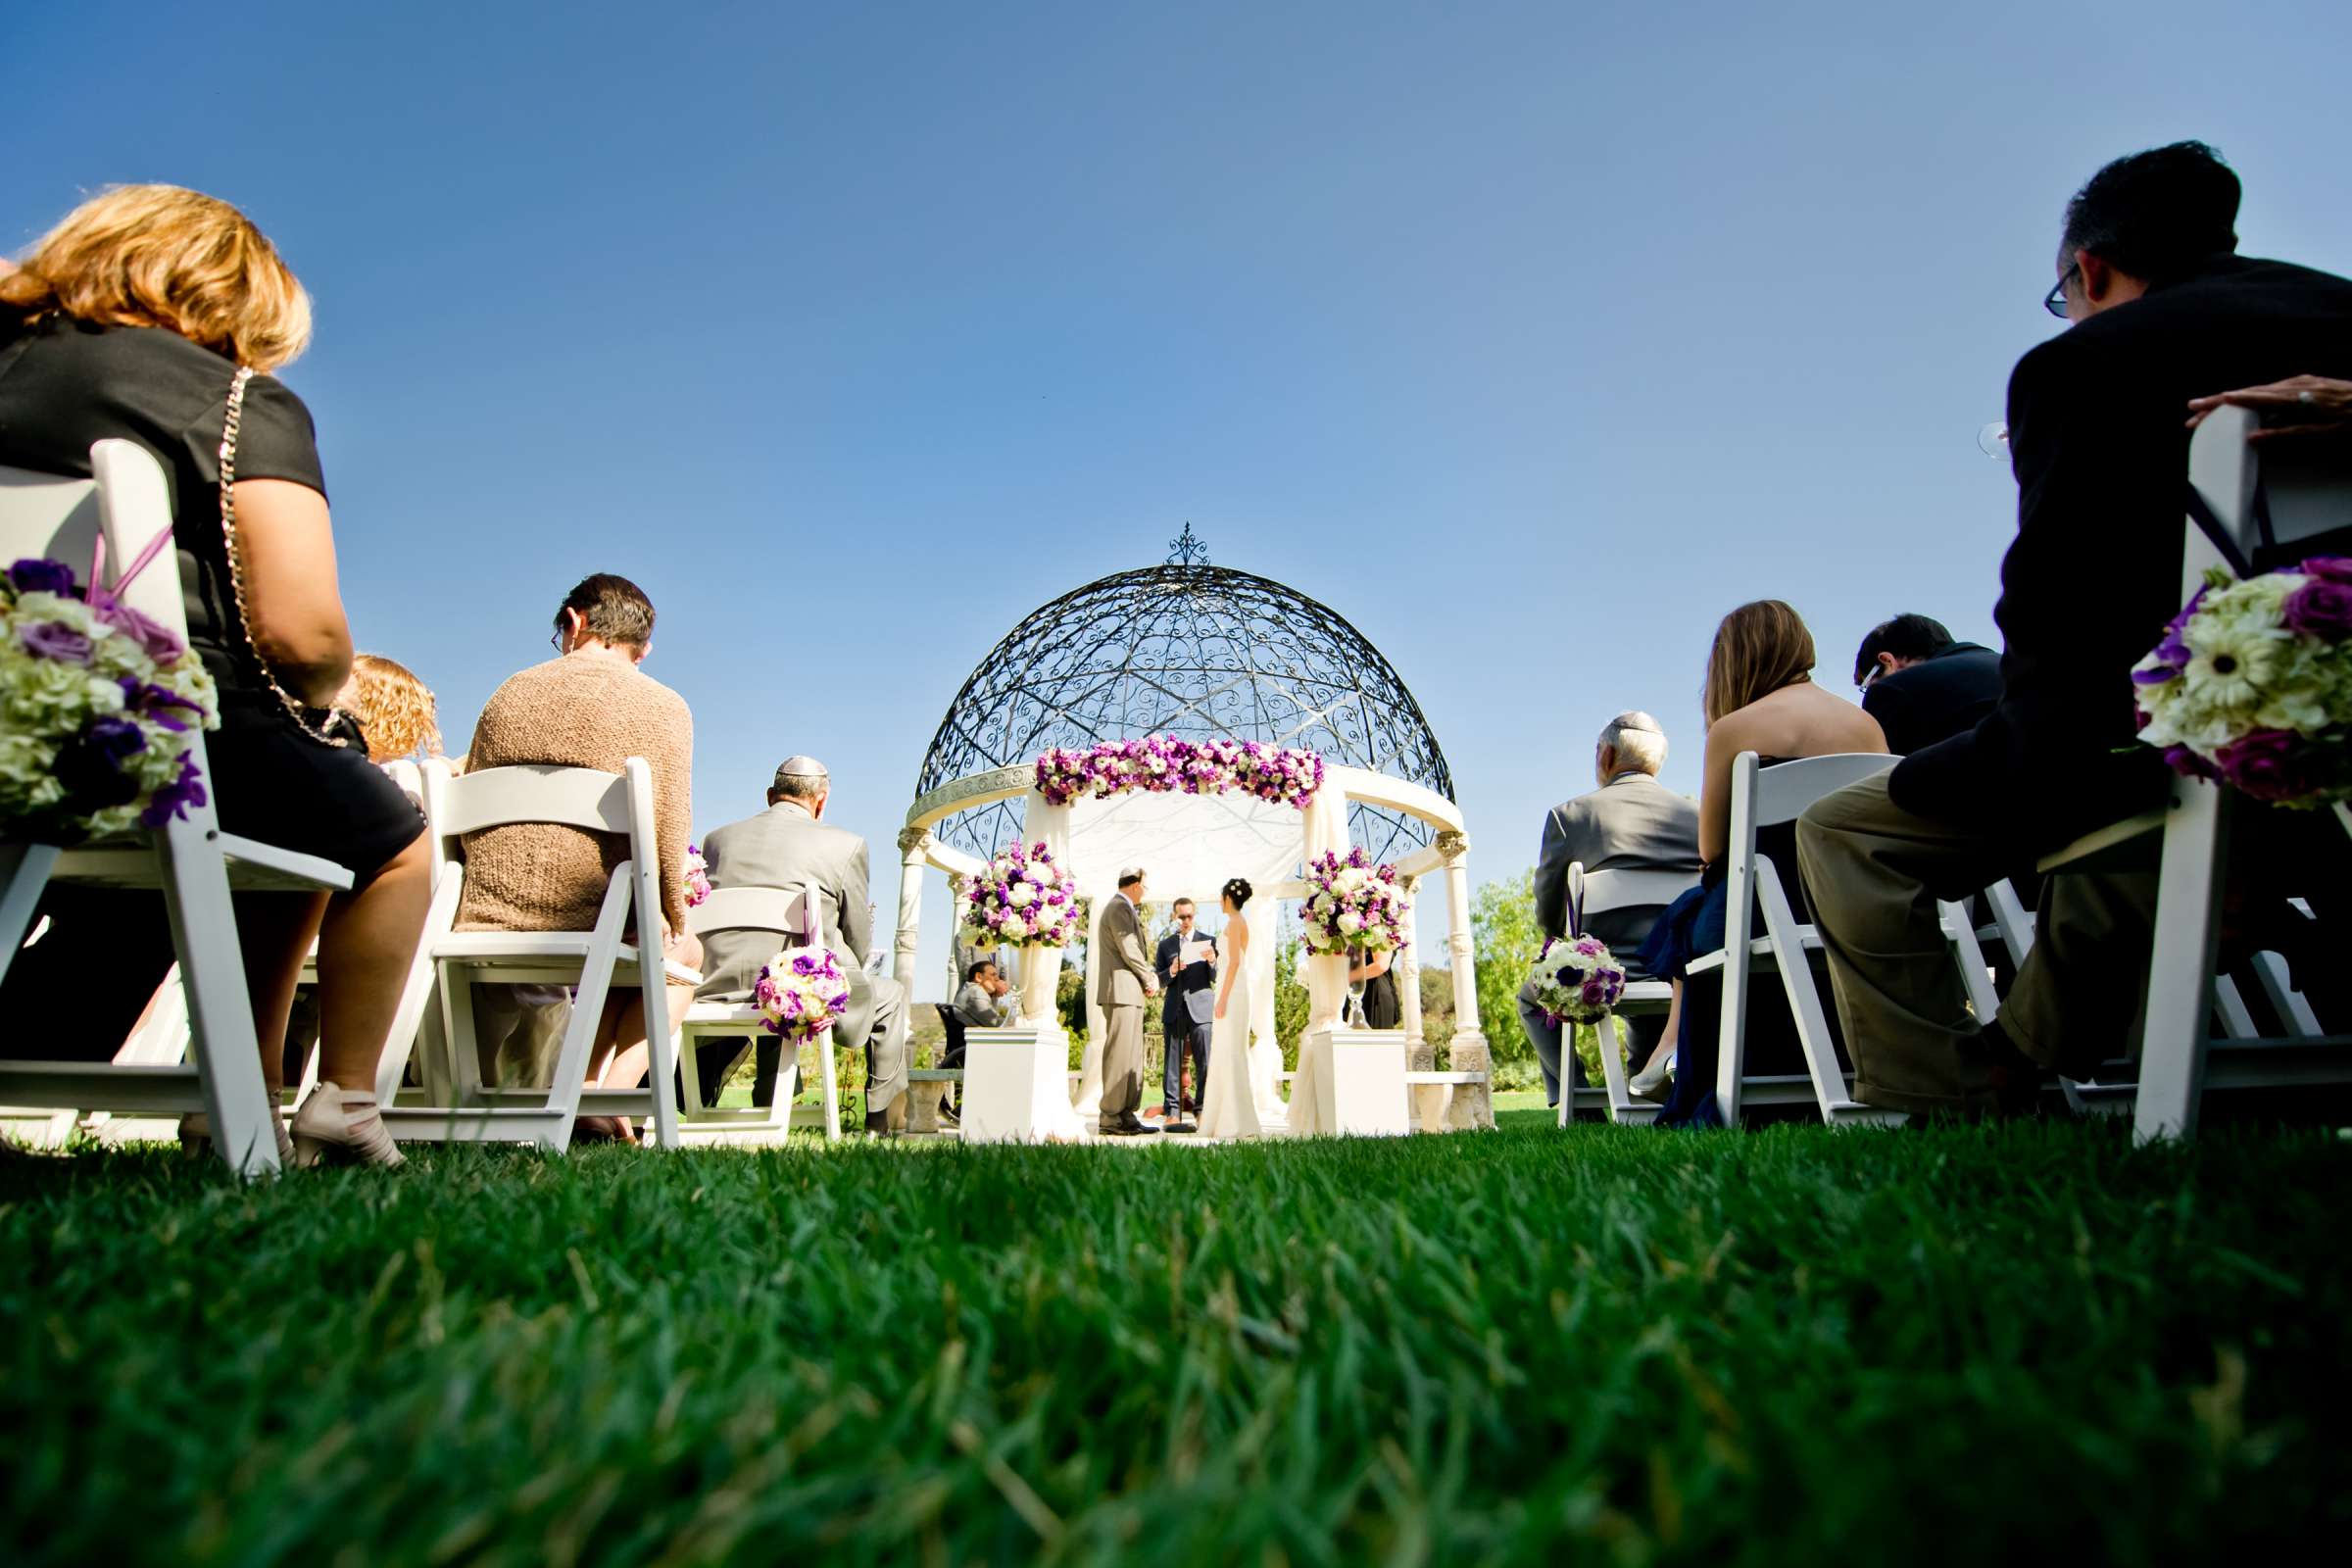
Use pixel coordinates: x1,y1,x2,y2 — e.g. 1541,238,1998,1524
457,571,701,1140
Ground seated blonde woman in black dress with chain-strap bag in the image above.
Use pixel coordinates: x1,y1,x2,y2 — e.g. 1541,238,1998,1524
0,186,433,1166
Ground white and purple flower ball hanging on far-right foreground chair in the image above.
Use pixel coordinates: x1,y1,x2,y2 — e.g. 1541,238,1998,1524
2131,555,2352,807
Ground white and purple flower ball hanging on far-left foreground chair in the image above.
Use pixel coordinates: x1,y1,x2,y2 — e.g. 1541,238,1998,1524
0,555,221,844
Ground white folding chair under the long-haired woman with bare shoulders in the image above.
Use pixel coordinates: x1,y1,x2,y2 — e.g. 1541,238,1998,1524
1687,753,1909,1126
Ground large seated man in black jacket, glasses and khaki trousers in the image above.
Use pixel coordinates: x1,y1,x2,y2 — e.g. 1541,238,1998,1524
1797,141,2352,1114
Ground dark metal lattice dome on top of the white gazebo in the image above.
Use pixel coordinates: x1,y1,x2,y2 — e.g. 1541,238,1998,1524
915,524,1453,860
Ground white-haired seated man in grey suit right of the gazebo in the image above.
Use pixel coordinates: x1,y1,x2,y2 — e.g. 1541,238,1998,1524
1519,712,1698,1107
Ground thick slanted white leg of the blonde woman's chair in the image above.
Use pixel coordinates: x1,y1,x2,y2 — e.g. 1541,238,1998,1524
155,820,277,1175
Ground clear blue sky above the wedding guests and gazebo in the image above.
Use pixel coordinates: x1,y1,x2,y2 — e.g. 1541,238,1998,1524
0,0,2352,995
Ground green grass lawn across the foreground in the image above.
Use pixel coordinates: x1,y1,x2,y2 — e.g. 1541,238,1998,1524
0,1114,2352,1566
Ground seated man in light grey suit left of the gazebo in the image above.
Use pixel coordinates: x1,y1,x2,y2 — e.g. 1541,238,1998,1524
694,757,907,1133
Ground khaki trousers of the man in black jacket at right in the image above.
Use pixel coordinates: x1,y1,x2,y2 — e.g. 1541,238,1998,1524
1797,773,2157,1112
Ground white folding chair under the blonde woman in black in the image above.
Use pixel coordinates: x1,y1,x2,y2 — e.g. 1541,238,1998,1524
0,440,353,1175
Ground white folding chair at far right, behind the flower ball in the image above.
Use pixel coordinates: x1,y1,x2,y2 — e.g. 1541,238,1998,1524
2041,409,2352,1140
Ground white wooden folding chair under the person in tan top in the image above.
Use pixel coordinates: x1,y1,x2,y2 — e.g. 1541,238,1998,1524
376,757,701,1150
